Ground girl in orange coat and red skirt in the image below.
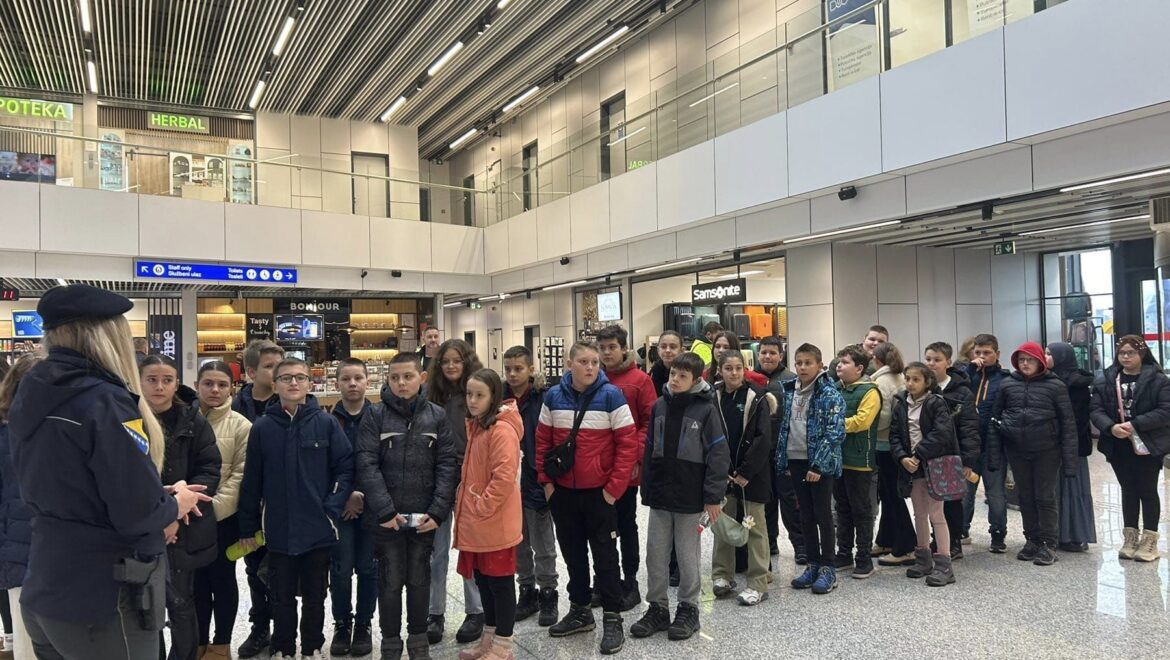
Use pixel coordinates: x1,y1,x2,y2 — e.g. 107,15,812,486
455,369,524,660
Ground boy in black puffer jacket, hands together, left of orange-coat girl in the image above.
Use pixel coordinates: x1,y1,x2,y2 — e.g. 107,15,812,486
357,353,459,658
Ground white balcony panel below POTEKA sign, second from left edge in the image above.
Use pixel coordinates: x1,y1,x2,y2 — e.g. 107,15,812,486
42,186,138,256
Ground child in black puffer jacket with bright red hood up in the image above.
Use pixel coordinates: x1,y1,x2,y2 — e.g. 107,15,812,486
987,342,1076,566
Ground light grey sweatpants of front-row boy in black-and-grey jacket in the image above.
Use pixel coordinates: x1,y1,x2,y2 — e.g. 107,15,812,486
646,509,703,609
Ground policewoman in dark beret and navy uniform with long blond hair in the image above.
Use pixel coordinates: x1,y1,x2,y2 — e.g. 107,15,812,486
8,284,211,660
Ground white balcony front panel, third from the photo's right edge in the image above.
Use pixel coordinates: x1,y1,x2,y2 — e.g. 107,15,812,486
787,78,882,194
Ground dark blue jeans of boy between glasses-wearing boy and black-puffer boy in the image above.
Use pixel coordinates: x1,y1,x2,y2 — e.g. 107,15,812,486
329,518,378,625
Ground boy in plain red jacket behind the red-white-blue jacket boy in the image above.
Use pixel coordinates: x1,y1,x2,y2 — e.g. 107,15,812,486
593,325,658,612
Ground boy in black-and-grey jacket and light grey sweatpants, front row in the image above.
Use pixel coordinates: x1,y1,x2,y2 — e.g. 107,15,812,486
629,353,730,640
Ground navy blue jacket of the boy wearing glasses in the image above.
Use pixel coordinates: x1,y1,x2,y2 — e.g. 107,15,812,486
239,394,353,556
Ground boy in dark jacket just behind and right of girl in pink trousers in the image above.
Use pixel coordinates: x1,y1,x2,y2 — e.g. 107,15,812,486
924,342,983,559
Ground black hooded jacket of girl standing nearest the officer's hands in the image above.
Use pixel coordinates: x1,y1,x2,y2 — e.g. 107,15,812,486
160,385,223,570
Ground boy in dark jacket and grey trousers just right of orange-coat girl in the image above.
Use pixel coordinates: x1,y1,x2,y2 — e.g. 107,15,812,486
504,346,559,626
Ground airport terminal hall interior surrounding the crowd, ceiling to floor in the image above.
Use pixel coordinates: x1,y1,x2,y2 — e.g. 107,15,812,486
0,0,1170,660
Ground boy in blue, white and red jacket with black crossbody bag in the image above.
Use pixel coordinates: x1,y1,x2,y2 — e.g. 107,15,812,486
536,342,641,654
